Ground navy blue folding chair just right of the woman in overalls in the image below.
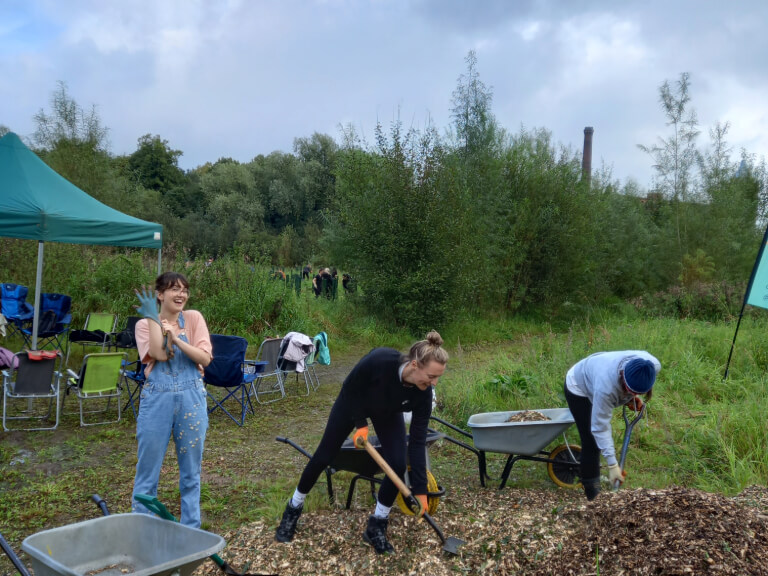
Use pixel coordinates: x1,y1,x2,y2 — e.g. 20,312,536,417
203,334,263,426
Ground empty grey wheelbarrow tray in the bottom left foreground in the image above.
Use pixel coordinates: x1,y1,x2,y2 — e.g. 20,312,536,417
21,514,225,576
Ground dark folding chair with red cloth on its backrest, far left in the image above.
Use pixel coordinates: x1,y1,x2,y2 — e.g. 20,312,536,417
2,351,61,431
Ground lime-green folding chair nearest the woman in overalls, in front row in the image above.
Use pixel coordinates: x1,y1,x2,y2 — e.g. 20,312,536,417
61,352,126,426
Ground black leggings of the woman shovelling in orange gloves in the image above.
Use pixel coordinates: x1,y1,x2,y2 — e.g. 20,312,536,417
298,396,407,506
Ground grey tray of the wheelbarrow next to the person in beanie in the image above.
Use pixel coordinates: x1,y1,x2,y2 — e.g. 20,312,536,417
467,408,574,456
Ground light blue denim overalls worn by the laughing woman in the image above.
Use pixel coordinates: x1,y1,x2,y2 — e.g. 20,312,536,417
133,313,208,528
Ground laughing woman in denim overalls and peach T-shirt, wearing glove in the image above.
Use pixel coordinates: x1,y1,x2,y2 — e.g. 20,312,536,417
133,272,212,528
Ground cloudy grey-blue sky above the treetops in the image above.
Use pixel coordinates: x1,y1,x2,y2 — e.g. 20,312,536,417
0,0,768,187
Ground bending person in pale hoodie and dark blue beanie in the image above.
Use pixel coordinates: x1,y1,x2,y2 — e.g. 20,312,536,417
565,350,661,500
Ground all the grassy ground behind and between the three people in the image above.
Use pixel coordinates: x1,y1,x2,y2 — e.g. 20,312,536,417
0,317,768,574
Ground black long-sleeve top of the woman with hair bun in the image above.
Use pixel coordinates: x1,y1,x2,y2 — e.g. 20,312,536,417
339,348,432,494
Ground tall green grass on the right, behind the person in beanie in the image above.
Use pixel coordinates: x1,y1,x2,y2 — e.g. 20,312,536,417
438,316,768,493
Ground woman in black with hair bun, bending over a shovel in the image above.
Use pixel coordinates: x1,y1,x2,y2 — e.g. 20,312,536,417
275,331,448,554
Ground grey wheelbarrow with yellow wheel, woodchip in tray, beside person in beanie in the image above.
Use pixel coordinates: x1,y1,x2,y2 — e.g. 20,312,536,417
431,408,581,489
